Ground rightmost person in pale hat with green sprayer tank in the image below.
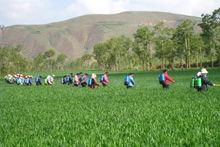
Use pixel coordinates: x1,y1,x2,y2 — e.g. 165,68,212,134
195,68,215,91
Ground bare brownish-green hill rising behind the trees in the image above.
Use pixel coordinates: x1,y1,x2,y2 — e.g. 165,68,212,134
0,12,200,59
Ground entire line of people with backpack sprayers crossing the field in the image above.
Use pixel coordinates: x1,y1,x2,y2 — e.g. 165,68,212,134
5,68,215,91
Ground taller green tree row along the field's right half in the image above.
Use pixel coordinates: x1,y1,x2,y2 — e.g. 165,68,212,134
93,8,220,70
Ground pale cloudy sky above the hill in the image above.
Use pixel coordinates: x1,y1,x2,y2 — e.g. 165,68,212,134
0,0,220,26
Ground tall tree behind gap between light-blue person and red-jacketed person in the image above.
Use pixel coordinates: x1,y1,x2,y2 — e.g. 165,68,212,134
133,26,154,70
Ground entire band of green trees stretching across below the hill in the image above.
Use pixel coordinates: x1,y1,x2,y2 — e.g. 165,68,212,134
0,8,220,74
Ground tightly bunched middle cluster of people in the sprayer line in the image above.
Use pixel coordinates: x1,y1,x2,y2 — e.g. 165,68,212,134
62,72,109,89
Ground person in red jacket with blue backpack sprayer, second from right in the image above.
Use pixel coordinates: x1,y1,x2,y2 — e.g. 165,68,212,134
159,69,175,89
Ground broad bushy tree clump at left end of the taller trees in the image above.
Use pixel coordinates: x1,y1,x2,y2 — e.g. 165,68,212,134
93,36,132,70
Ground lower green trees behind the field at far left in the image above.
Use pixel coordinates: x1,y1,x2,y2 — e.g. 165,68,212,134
0,46,66,75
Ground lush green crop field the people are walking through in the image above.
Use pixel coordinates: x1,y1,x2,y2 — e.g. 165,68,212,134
0,69,220,146
